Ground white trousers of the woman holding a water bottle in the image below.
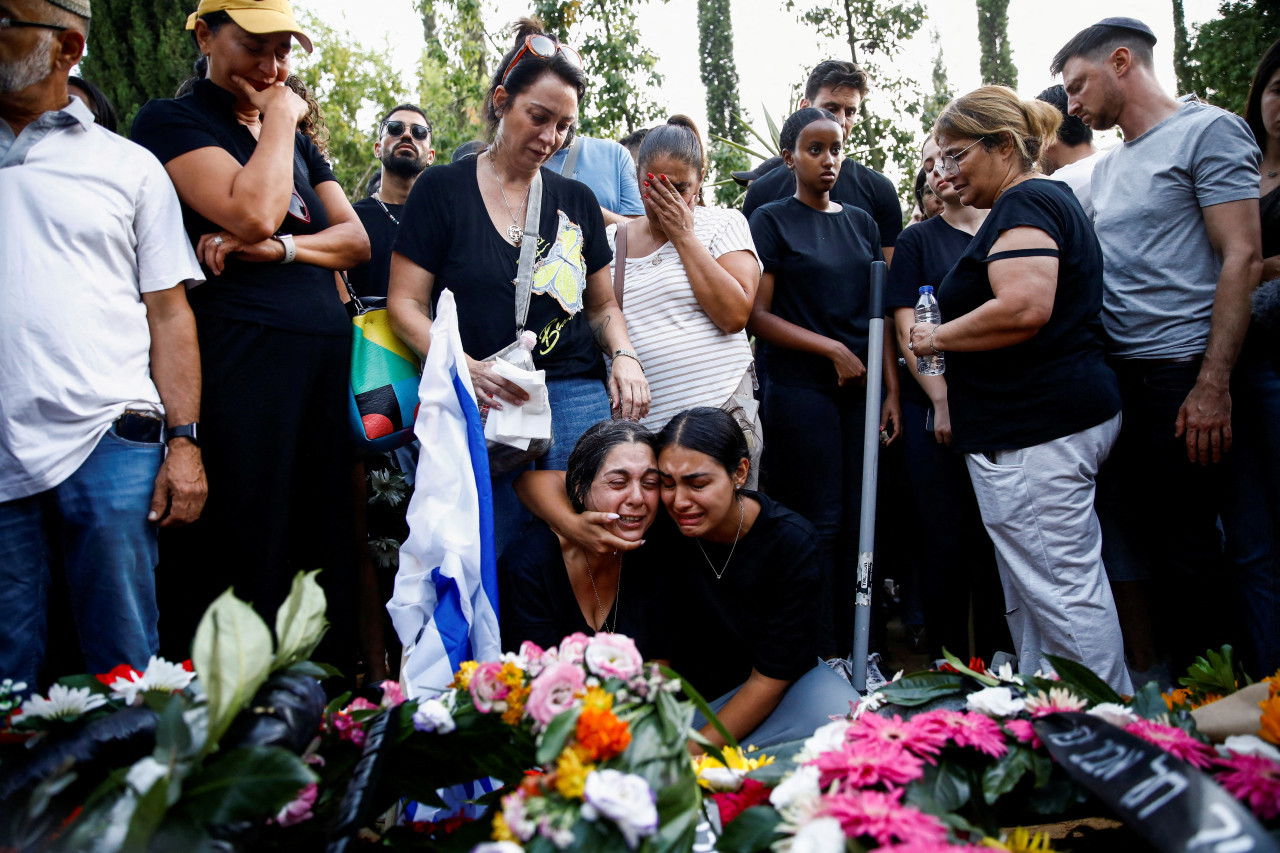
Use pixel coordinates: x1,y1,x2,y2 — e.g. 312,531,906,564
966,415,1133,694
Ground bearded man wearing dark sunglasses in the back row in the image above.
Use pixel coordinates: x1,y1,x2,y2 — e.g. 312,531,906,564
347,104,435,297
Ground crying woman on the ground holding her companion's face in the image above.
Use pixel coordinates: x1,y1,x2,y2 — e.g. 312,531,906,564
516,407,858,747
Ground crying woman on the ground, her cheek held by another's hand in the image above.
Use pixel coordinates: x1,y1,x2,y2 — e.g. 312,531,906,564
498,420,667,660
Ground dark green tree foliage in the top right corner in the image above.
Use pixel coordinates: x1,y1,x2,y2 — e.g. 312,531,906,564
1178,0,1280,114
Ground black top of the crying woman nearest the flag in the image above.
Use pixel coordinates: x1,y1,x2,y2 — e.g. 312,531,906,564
498,521,671,661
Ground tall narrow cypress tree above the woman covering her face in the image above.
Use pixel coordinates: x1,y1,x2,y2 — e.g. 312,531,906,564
698,0,749,205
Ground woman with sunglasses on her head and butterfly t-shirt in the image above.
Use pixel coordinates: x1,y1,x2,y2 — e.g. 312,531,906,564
388,19,649,552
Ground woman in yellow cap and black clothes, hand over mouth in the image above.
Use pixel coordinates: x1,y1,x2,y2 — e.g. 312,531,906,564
133,0,369,671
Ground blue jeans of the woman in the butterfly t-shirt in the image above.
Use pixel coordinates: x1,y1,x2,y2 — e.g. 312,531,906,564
493,379,609,556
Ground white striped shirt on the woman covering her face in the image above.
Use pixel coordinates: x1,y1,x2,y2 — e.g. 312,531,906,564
605,207,759,430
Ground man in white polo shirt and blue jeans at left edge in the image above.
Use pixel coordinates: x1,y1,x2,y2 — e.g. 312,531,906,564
0,0,206,688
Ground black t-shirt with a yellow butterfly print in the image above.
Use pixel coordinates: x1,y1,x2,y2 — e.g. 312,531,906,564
396,158,613,379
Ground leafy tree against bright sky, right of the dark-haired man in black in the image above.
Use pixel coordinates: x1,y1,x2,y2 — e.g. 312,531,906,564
787,0,924,204
